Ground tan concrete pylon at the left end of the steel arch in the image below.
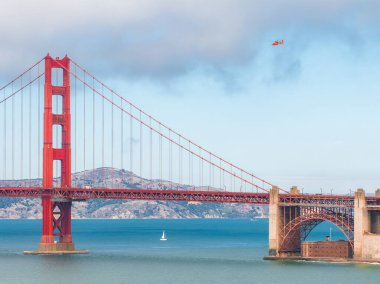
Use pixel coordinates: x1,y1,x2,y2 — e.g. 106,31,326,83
269,186,280,256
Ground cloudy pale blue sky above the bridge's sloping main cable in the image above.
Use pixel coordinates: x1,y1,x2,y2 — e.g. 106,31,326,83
0,0,380,193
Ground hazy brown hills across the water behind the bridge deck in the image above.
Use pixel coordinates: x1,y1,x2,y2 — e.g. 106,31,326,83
0,168,268,219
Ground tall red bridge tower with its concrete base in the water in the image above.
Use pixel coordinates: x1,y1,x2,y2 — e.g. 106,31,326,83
38,54,75,253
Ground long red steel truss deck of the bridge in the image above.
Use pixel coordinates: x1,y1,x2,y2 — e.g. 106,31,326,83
0,187,380,208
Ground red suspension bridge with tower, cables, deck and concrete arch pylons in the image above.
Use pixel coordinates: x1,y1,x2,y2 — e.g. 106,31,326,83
0,54,380,258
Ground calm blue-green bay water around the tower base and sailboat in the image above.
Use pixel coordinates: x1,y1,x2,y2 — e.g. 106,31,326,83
0,219,380,284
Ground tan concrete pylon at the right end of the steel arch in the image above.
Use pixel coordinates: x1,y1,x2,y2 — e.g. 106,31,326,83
354,188,369,258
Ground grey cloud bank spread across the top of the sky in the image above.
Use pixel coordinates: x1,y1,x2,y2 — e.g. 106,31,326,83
0,0,380,80
